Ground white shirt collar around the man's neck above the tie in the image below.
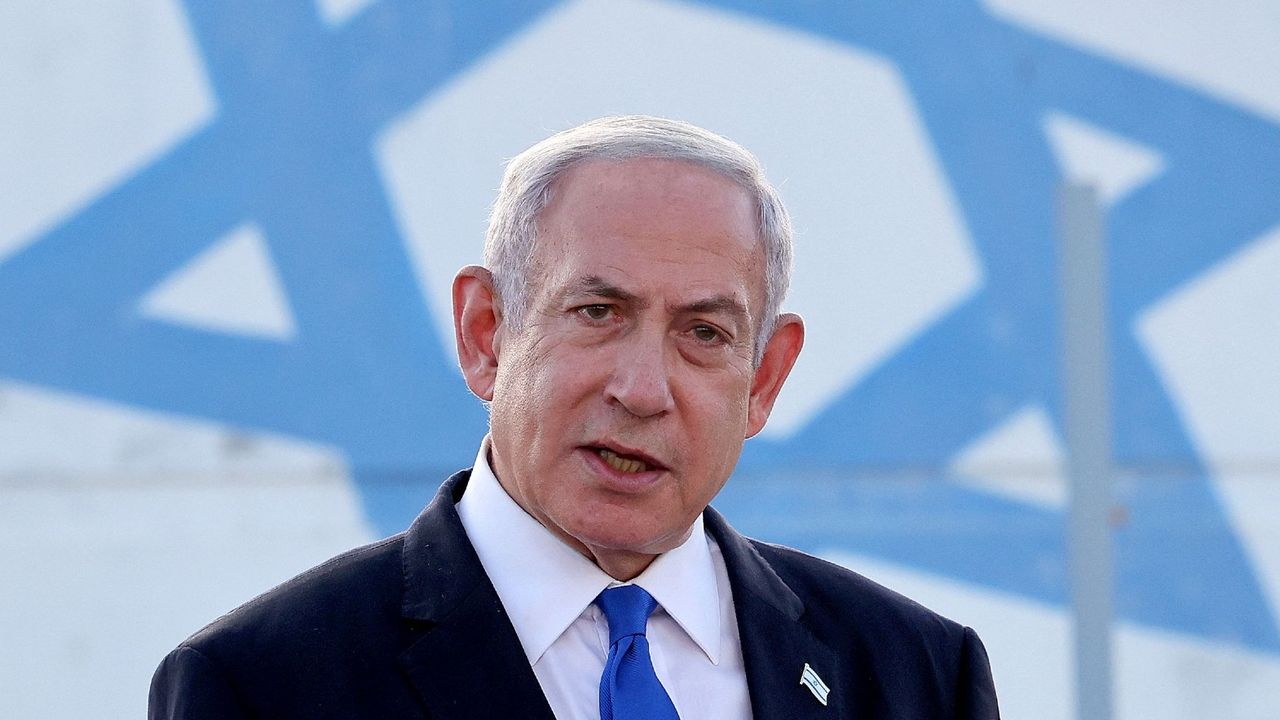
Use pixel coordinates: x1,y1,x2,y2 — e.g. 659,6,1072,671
458,437,721,665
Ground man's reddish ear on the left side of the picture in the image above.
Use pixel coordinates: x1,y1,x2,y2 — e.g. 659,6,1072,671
453,265,502,401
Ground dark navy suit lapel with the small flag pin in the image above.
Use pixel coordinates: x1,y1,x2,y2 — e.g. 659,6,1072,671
705,507,854,720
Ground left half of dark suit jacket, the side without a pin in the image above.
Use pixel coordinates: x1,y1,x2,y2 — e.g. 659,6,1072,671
150,473,550,720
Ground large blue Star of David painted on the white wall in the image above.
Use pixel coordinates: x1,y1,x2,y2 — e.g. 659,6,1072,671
0,0,1280,653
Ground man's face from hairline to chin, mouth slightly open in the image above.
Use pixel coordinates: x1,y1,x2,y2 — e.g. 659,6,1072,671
465,159,799,574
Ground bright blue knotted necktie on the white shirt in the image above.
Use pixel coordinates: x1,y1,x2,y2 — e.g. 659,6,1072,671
595,585,680,720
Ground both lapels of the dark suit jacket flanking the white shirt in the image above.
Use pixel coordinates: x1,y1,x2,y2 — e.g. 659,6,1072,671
399,471,852,720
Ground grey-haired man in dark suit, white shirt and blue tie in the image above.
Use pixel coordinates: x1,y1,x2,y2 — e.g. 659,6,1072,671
151,117,997,720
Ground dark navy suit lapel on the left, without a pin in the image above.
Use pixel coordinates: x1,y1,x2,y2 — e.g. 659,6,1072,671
389,473,553,720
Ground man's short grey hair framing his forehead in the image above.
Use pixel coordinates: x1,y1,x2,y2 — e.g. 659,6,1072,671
484,115,791,363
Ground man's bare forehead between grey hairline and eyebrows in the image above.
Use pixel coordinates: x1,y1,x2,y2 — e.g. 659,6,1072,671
531,158,765,309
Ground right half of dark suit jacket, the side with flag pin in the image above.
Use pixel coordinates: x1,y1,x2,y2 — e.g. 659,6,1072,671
707,510,998,720
